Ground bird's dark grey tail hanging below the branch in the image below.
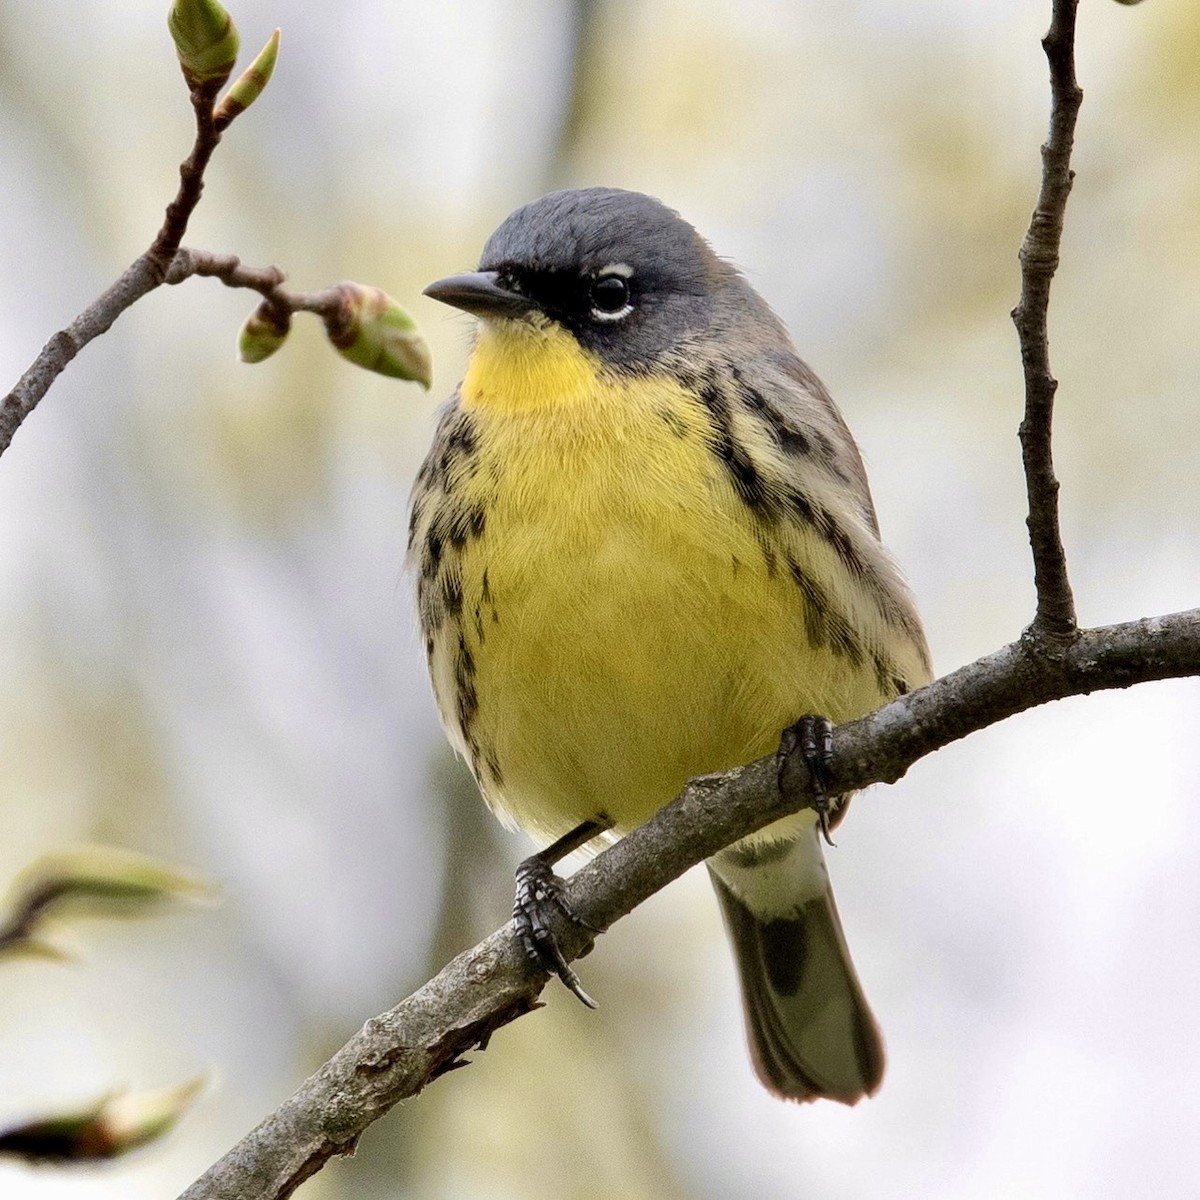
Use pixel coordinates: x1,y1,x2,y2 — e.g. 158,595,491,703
708,830,883,1104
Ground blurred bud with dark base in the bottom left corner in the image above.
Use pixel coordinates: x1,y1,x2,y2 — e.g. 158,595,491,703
0,1075,208,1163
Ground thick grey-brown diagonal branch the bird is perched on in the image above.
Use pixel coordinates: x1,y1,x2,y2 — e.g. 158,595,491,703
180,608,1200,1200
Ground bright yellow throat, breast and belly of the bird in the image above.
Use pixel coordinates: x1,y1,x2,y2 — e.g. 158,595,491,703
431,323,902,840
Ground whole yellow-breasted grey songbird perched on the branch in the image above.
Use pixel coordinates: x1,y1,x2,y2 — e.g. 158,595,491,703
409,187,931,1104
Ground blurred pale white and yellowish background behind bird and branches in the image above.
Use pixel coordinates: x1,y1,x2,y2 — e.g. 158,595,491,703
0,0,1200,1200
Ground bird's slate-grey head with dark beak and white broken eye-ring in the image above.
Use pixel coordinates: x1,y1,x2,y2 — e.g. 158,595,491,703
425,187,774,367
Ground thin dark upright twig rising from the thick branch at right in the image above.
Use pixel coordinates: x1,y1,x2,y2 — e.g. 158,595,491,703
1013,0,1084,643
